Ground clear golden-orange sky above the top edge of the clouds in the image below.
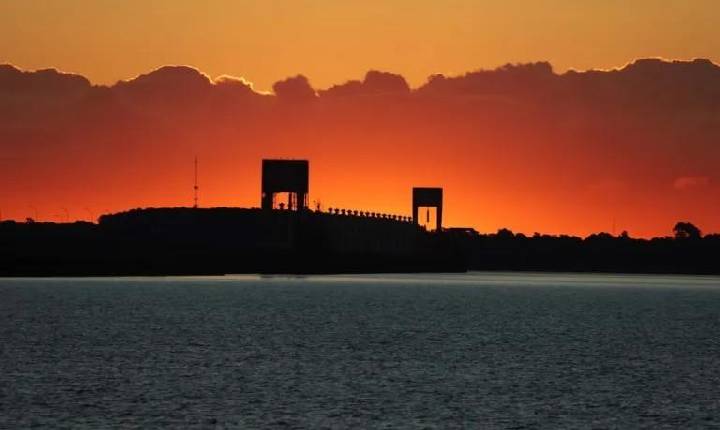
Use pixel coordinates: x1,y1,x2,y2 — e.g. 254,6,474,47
0,0,720,90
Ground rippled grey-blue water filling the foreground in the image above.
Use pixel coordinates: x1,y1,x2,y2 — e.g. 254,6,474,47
0,274,720,428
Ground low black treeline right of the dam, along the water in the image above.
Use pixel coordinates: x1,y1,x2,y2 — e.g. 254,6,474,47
456,222,720,274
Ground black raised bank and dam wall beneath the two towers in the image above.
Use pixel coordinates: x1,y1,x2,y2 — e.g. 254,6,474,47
0,208,466,275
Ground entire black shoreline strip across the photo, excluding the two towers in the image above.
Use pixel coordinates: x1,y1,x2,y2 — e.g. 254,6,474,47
0,208,720,276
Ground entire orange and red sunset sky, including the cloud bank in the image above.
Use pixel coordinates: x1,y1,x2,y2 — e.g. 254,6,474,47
0,0,720,237
